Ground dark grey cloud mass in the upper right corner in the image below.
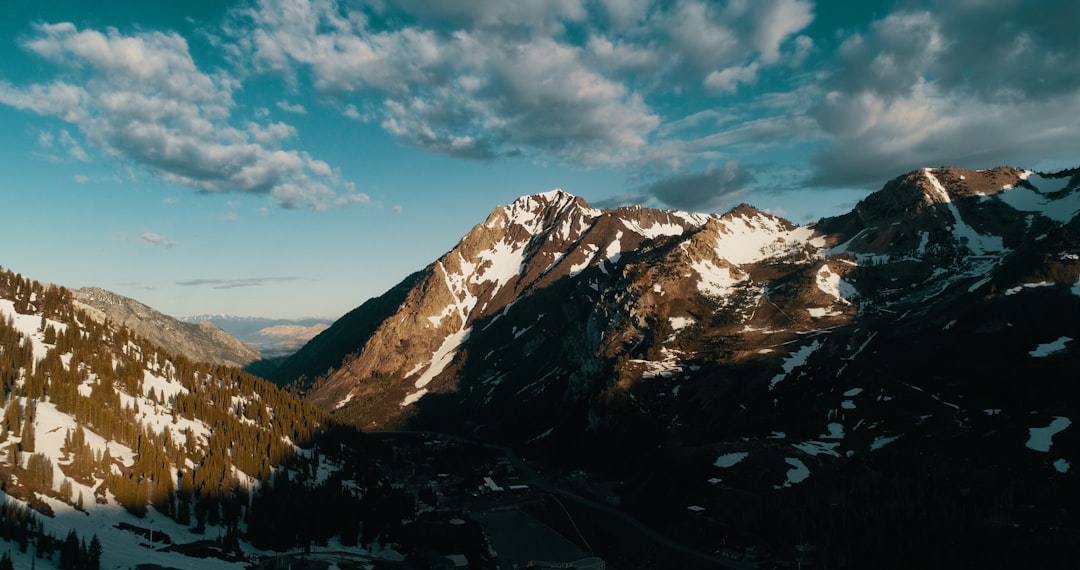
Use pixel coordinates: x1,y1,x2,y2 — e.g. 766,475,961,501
812,1,1080,186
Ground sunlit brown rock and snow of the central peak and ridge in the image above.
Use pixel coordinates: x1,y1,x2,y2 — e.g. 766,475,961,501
298,190,813,421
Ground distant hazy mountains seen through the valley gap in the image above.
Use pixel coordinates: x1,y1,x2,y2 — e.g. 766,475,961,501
177,314,333,364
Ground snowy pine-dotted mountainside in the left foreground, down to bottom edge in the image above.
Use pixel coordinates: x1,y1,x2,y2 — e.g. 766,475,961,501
0,269,349,569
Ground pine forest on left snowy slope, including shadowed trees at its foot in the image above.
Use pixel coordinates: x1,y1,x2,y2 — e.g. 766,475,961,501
0,268,451,569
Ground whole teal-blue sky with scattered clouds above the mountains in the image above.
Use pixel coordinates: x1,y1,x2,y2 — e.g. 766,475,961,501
0,0,1080,318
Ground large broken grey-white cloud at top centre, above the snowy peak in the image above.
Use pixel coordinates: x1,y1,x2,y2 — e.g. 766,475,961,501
227,0,812,165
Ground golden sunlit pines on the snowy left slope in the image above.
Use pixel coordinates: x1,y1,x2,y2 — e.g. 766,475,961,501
0,268,326,546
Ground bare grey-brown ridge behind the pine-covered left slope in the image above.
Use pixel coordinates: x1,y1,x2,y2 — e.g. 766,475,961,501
72,287,261,366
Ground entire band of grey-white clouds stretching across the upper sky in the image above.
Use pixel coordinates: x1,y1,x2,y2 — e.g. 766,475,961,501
0,0,1080,209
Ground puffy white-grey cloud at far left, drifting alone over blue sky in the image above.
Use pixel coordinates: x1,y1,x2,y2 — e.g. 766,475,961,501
0,23,365,208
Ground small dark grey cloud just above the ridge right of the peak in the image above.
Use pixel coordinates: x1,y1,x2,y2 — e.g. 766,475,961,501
645,161,754,212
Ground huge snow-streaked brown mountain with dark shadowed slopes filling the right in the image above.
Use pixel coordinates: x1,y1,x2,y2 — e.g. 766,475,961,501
274,167,1080,568
